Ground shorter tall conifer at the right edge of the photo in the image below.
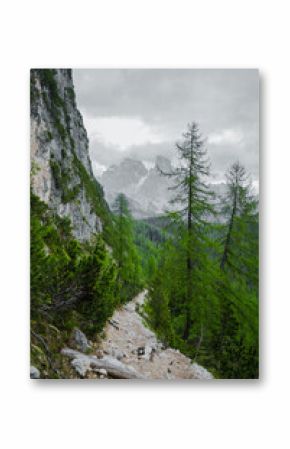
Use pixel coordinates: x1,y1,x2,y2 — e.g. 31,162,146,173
217,162,258,378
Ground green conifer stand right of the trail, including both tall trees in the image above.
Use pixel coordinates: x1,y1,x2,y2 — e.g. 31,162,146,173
143,126,259,379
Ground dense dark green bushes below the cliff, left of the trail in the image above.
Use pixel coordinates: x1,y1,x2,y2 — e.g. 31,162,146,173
30,193,118,377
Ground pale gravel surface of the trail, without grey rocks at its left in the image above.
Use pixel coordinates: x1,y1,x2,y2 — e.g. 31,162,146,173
100,291,213,380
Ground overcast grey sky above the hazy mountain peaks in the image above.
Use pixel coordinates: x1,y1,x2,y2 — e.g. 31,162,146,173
73,69,259,182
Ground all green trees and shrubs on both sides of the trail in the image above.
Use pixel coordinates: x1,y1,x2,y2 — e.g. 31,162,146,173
31,70,259,378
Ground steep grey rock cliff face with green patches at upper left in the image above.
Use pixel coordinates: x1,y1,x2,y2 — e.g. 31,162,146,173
31,69,109,241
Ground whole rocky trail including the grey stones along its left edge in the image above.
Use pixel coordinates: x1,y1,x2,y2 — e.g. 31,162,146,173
62,290,213,380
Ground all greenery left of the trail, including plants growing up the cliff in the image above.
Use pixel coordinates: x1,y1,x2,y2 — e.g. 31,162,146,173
31,69,148,378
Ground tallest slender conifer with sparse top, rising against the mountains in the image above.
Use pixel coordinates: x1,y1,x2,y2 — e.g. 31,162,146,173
159,122,213,340
